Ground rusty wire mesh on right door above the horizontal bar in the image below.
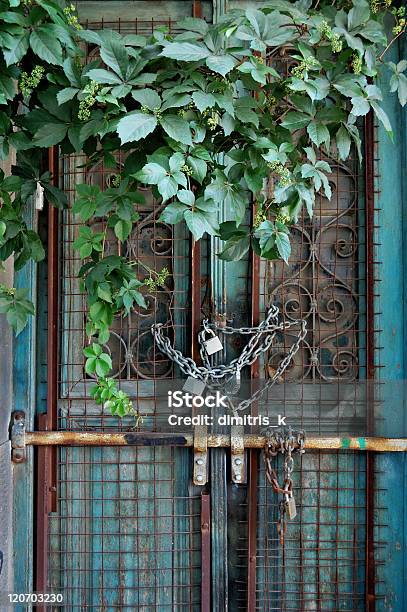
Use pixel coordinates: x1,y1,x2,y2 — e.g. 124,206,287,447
253,52,379,435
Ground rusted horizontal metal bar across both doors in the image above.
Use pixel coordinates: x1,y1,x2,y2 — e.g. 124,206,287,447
19,431,407,452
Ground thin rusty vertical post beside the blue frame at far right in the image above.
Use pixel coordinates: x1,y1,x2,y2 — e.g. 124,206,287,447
364,112,376,612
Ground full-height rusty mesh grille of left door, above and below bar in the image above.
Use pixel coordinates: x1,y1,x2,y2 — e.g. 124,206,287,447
48,15,201,612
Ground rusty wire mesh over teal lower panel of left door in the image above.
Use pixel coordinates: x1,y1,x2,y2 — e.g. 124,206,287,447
49,448,201,612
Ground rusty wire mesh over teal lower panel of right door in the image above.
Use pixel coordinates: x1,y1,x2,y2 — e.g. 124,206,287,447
256,451,385,612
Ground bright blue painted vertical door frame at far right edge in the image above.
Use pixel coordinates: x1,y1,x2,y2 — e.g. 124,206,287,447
375,34,407,612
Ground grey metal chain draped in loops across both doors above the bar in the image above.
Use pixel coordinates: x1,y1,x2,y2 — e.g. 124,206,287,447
151,305,307,412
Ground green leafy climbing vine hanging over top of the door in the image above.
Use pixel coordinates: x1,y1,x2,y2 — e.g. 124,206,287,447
0,0,407,416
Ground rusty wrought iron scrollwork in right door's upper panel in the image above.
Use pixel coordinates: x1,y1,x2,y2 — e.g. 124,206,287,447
266,160,360,382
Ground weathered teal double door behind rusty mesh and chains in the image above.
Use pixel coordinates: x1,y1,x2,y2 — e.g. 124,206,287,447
9,0,404,612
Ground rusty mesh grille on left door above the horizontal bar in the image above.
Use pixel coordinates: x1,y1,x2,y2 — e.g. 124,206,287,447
59,19,191,429
